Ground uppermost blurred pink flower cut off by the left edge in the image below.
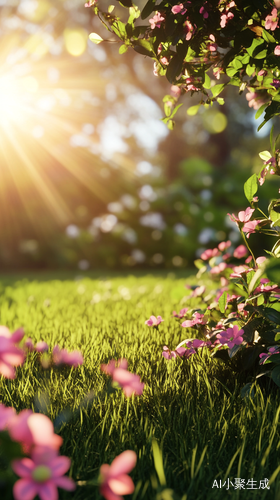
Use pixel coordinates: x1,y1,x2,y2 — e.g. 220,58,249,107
0,326,25,378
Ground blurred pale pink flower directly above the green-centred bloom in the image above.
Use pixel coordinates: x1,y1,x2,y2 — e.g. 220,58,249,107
8,410,63,453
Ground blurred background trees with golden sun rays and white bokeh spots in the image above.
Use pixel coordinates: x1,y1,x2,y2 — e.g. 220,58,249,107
0,0,276,271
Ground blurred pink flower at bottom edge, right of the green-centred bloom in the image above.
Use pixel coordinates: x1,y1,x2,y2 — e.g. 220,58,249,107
100,450,137,500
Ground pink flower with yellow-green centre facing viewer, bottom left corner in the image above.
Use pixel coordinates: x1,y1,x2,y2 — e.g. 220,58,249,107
12,449,76,500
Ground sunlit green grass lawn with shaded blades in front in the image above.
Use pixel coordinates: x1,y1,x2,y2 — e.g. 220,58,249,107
0,272,280,500
